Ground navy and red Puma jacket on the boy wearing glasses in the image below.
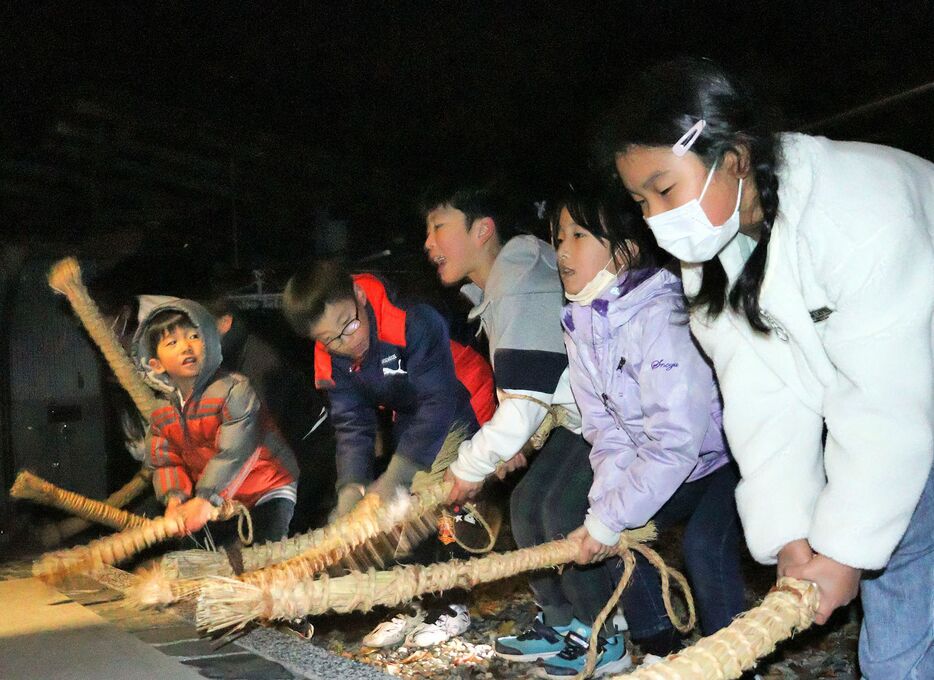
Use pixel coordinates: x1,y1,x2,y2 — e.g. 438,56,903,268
315,274,495,486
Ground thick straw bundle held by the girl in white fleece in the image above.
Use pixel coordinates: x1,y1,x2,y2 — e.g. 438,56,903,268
612,577,818,680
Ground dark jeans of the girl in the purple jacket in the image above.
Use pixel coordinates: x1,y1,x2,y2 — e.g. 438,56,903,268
614,465,746,640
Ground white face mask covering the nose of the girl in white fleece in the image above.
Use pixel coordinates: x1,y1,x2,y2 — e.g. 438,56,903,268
645,163,743,262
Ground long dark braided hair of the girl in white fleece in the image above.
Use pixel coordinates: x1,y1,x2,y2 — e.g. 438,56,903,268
600,58,780,333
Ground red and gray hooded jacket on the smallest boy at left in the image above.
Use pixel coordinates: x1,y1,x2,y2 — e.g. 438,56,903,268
134,300,298,507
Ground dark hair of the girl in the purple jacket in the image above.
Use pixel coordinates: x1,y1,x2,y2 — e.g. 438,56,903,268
548,179,668,270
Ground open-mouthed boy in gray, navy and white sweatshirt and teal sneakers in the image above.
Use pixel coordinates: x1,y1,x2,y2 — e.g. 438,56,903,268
421,178,617,672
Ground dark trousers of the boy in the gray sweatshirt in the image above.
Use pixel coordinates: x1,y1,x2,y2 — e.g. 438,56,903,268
509,427,616,635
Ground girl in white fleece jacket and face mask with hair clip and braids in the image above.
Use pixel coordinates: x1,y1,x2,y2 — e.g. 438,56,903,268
608,60,934,679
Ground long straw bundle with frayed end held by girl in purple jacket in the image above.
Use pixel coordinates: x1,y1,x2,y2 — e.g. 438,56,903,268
197,525,668,632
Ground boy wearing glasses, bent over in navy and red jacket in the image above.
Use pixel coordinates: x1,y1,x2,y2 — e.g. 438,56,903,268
282,262,493,516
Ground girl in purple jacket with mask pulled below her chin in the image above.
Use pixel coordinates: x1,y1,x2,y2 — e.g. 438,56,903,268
551,190,745,656
